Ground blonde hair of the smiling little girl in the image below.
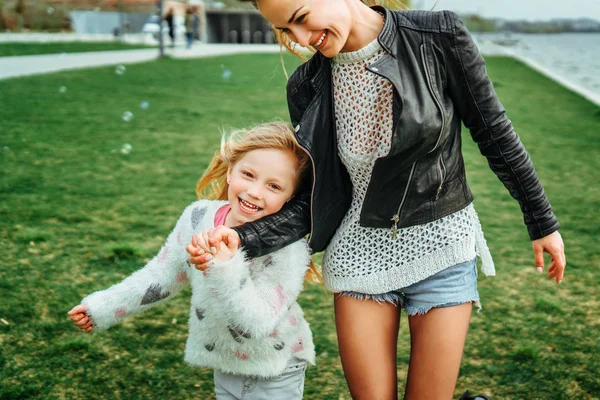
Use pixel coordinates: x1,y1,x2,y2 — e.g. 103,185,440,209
196,121,321,282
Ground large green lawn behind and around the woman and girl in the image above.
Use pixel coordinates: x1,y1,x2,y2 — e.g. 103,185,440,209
0,55,600,400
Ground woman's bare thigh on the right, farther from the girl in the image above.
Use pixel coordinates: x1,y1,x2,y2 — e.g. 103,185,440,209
404,303,473,400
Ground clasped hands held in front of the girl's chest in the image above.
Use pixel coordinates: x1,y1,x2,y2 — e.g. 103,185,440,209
185,225,240,271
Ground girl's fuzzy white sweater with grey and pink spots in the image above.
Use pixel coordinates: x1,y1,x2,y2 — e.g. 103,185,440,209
82,200,315,378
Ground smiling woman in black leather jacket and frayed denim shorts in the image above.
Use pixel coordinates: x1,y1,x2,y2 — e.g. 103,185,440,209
191,0,565,399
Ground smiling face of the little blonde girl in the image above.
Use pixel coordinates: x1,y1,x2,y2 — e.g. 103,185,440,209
225,149,298,226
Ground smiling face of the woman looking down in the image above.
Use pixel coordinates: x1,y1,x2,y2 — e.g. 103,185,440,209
258,0,352,58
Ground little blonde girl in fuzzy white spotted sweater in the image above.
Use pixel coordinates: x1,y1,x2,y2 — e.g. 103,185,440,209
68,122,316,399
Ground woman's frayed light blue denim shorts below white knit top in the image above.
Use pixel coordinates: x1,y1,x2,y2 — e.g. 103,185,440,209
340,259,481,315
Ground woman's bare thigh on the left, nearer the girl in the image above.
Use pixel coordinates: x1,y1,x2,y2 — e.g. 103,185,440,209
334,295,400,400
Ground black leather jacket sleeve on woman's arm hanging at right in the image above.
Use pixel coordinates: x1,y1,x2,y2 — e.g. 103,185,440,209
446,12,559,240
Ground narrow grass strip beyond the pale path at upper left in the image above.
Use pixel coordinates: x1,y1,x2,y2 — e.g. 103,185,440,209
0,41,156,57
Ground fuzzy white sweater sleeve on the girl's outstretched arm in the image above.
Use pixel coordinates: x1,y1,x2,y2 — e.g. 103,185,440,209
81,206,199,331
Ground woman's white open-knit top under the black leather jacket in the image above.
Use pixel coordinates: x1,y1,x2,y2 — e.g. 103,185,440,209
323,40,495,294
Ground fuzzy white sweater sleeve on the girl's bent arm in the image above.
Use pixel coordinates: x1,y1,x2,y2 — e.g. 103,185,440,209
206,240,310,338
